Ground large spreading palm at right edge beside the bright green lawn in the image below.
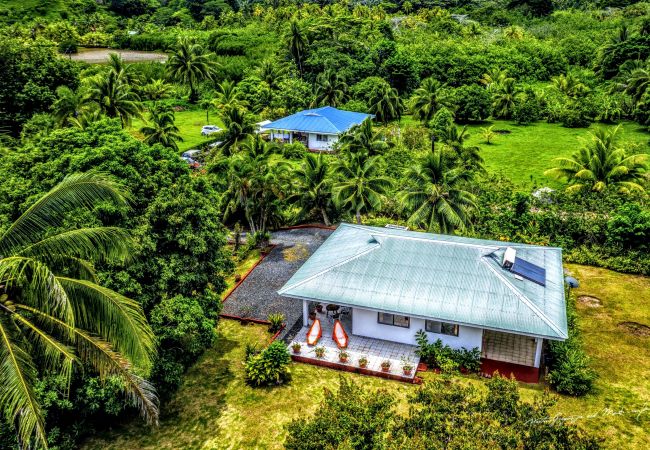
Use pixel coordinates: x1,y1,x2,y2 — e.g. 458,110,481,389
544,125,650,194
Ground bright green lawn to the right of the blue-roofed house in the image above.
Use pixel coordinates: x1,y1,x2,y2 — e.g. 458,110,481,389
402,116,650,188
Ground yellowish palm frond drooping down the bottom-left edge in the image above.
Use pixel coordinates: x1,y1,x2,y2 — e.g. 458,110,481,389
0,314,47,447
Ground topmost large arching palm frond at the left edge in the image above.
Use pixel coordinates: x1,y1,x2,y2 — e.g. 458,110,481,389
0,172,127,255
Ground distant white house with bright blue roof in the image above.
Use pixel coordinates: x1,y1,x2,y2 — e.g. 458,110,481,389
260,106,372,151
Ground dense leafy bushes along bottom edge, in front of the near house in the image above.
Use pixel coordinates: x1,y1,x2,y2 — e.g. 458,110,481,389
285,377,600,449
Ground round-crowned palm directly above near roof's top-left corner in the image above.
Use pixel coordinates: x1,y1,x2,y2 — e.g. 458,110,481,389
332,152,392,224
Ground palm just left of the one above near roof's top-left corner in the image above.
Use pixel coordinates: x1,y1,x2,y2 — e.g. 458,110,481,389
287,153,332,226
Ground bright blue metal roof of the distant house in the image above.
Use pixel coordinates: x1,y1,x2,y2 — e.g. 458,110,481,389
262,106,372,134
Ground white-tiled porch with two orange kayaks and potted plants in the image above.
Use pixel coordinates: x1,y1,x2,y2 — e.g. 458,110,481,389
290,301,420,382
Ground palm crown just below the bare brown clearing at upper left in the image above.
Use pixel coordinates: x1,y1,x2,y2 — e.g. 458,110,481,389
84,70,142,128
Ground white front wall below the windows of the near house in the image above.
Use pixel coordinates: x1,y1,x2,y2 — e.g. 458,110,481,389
352,308,483,350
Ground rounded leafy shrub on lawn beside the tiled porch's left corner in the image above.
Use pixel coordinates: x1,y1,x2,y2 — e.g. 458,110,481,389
246,341,291,386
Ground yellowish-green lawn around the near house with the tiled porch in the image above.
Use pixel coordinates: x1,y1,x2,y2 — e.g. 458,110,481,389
84,265,650,450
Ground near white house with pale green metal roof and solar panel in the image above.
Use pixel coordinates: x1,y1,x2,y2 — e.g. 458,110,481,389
279,223,568,382
